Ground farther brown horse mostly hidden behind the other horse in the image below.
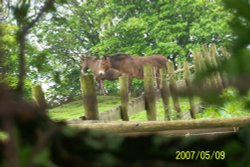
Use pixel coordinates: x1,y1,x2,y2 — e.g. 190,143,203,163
81,56,122,95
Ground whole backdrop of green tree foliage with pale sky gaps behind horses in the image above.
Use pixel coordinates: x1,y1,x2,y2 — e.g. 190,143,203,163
0,0,235,102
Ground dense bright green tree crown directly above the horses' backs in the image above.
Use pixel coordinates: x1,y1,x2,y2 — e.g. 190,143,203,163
92,0,231,61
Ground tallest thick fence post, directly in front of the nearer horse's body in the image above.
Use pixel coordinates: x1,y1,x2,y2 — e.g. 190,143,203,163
143,64,156,121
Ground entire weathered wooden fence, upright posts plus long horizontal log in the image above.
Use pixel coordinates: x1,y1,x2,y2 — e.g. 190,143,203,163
29,45,244,136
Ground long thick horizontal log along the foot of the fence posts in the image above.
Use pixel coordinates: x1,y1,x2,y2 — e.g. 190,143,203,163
69,116,250,133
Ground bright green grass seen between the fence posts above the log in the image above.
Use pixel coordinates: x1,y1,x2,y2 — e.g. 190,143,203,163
49,92,250,121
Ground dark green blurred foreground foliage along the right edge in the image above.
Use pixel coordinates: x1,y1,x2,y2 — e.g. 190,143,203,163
193,0,250,108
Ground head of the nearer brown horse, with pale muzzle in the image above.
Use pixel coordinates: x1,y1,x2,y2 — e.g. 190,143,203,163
97,56,111,77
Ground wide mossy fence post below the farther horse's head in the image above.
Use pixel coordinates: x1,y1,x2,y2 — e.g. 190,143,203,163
80,75,99,120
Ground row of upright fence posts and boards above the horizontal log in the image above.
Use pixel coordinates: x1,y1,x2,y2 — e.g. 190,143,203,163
75,45,228,121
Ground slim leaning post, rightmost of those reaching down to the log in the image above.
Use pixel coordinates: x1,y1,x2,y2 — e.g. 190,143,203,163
183,62,195,119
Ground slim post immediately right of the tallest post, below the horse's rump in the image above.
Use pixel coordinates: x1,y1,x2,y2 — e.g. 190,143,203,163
160,69,170,120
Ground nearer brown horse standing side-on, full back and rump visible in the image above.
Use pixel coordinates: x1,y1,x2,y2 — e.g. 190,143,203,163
98,53,168,88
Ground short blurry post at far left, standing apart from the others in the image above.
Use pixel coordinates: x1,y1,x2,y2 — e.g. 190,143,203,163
32,85,47,112
